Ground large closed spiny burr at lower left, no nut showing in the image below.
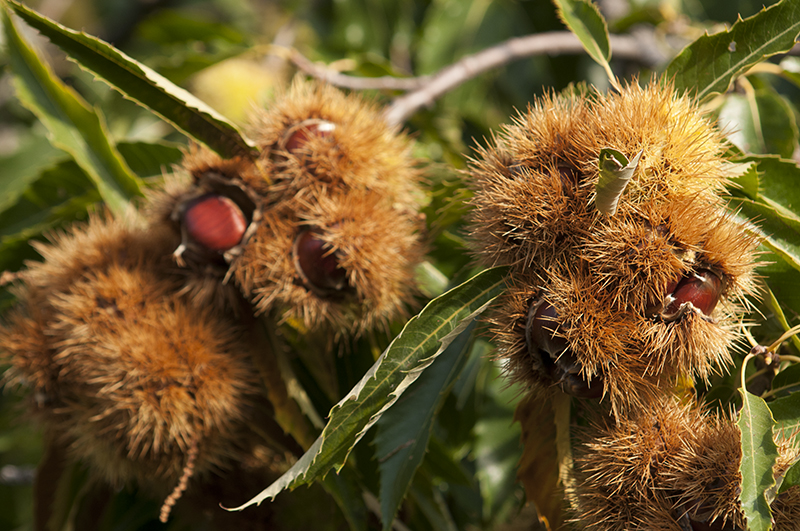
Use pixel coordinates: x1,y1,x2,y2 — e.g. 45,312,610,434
0,214,288,488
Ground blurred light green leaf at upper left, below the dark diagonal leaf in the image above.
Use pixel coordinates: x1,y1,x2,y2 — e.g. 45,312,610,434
2,6,142,214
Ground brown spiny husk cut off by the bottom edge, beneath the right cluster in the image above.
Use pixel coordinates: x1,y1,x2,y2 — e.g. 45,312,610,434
573,396,744,531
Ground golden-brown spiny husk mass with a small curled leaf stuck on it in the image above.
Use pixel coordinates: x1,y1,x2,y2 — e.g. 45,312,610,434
470,82,757,413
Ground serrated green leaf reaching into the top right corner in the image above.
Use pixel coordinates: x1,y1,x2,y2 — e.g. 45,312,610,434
663,0,800,102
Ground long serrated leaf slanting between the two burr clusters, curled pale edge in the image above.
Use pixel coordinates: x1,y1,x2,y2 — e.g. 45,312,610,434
231,267,506,510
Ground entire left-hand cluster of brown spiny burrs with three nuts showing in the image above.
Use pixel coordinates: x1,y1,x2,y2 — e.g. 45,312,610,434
0,82,424,524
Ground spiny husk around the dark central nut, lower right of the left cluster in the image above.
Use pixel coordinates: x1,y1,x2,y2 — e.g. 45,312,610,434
233,190,424,333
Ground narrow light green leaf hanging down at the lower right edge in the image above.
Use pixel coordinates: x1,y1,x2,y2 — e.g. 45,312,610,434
736,389,778,531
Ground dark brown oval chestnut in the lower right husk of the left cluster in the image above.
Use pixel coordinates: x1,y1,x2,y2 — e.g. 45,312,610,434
292,230,347,295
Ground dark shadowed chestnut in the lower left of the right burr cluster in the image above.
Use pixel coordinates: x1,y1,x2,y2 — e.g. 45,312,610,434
525,301,603,398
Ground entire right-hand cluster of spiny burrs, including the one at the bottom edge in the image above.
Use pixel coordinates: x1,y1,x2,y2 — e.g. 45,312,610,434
470,82,800,531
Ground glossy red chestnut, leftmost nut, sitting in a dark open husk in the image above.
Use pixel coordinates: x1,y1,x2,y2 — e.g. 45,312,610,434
182,194,247,252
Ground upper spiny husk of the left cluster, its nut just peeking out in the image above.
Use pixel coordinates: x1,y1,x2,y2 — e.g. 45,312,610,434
251,78,420,212
